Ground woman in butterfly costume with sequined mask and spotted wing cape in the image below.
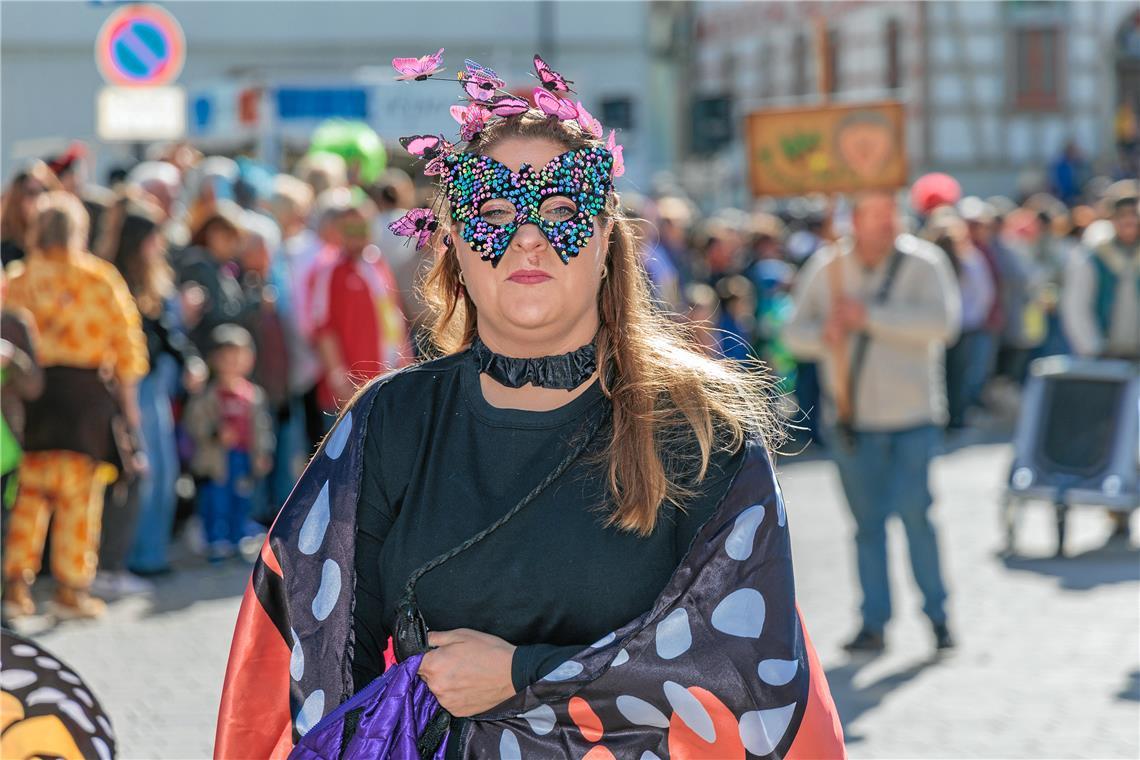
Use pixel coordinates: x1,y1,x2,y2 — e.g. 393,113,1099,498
215,50,845,760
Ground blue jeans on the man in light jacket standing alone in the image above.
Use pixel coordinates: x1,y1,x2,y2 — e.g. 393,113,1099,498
830,425,946,635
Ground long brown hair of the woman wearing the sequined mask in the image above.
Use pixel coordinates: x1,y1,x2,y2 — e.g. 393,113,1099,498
421,112,781,536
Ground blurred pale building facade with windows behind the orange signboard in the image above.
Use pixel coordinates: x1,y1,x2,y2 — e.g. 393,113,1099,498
689,0,1140,203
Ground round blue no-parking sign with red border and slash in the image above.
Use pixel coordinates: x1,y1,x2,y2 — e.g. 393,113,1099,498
95,5,186,87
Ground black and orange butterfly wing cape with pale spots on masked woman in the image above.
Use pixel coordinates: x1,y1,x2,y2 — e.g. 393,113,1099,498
214,382,846,760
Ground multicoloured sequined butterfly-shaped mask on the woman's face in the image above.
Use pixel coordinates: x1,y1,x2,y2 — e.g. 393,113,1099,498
443,148,613,267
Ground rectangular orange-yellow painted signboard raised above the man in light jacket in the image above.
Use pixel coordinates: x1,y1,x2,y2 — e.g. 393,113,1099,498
747,101,906,196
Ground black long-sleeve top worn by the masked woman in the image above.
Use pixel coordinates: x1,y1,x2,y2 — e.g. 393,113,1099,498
352,352,743,690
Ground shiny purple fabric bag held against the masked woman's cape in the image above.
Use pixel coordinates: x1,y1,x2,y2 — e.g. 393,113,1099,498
288,654,447,760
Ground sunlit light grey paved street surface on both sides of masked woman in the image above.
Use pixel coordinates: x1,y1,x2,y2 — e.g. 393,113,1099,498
11,437,1140,758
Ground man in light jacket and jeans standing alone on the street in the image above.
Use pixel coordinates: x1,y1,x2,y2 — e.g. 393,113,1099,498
784,193,961,652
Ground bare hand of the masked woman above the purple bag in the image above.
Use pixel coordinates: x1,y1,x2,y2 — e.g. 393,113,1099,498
420,628,514,718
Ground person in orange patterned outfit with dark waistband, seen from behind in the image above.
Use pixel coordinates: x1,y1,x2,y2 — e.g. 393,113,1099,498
3,191,147,618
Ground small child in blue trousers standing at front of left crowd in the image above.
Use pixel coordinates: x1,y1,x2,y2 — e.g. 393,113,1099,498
182,325,274,562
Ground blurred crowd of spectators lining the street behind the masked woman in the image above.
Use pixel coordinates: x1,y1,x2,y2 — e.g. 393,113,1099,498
0,135,1140,618
